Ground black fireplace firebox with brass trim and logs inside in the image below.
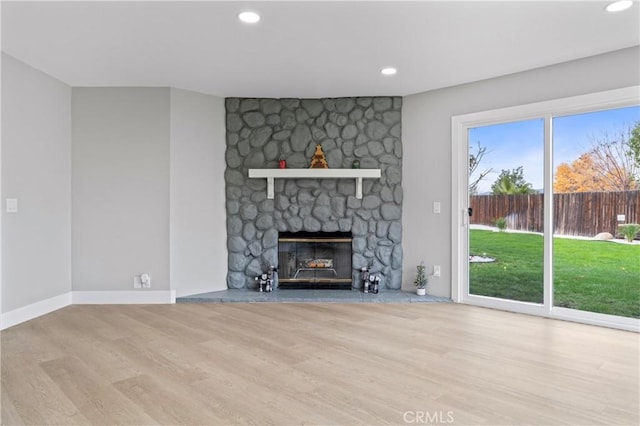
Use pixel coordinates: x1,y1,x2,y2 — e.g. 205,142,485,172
278,232,352,290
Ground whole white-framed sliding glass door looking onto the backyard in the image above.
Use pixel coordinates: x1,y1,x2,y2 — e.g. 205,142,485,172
452,87,640,331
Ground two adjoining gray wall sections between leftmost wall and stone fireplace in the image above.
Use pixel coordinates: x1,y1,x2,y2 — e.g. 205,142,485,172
72,88,227,296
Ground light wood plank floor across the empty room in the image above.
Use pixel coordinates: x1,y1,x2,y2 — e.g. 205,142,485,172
1,303,640,425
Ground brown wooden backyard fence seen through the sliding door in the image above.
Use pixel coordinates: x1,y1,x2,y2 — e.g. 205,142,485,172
470,190,640,237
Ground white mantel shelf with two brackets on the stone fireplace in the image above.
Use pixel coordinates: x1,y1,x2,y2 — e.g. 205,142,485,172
249,169,381,199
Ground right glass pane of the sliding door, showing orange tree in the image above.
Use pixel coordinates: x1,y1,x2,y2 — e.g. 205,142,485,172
553,106,640,318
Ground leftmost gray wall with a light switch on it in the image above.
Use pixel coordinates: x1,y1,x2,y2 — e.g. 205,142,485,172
1,53,71,312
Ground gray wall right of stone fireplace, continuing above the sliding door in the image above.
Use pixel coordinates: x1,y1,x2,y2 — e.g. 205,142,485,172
402,47,640,297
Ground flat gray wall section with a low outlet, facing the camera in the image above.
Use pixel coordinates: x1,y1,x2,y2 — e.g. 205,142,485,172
72,88,170,292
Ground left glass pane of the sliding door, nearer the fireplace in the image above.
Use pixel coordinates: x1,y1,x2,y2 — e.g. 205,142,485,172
468,119,544,304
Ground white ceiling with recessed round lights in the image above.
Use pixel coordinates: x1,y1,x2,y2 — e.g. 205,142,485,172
2,1,640,98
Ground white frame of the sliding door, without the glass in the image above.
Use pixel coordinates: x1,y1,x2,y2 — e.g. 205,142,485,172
451,86,640,332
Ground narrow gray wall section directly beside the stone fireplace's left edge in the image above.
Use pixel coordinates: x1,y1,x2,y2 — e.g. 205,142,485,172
170,89,227,297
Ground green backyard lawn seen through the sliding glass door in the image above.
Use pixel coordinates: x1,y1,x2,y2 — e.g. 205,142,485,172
469,230,640,318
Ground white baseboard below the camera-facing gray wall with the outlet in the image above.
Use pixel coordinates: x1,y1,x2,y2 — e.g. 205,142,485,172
73,290,176,305
